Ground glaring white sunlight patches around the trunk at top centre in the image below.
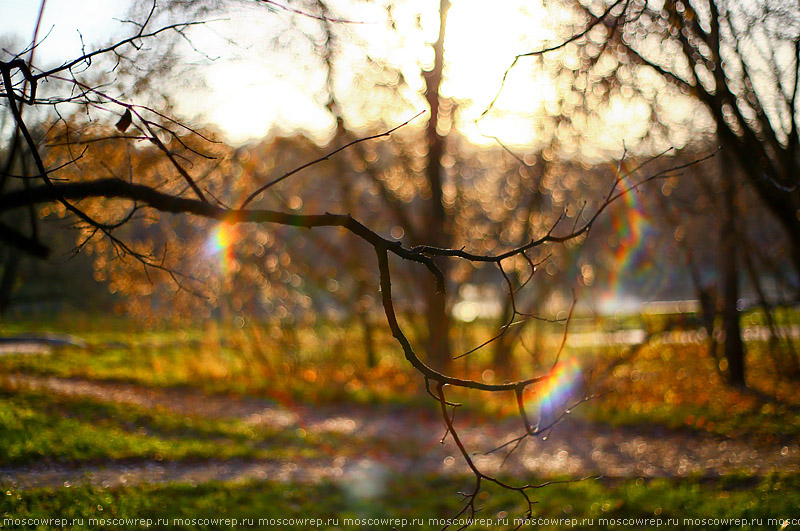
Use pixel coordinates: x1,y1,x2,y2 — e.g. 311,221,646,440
187,0,556,145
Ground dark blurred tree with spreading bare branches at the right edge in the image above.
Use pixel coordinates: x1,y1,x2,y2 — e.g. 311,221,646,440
512,0,800,386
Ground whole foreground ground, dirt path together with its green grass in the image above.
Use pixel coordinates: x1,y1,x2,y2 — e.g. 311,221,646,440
0,326,800,529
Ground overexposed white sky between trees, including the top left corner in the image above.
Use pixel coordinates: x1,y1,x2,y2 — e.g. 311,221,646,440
0,0,664,154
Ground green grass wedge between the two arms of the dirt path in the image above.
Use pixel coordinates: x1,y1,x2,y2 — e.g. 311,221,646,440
0,387,317,464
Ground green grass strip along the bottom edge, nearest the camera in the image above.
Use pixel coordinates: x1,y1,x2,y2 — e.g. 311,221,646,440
0,475,800,529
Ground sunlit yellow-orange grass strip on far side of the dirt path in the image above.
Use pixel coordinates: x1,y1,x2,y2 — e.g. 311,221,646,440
0,313,800,442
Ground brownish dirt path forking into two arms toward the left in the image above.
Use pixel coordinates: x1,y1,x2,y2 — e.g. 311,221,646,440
0,374,800,486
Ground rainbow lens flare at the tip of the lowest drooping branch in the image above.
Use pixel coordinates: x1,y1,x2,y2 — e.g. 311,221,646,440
523,358,583,428
